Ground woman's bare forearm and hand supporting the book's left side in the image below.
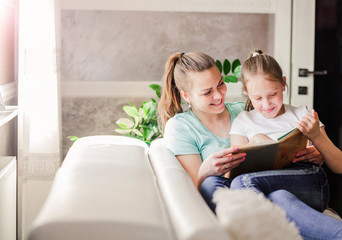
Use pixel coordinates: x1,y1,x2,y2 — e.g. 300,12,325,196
176,148,246,189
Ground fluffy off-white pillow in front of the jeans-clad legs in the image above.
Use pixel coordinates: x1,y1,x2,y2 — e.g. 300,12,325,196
213,188,302,240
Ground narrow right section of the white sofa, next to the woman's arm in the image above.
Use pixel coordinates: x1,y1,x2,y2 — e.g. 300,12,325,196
149,139,231,240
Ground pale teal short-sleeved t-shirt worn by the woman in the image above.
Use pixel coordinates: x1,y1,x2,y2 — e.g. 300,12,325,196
164,102,245,161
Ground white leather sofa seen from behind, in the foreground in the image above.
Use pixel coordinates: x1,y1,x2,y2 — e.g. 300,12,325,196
28,136,231,240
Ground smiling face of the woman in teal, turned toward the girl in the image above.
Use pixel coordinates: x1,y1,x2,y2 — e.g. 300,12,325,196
182,66,227,114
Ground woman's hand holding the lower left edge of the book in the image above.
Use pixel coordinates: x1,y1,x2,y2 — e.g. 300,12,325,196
199,148,246,177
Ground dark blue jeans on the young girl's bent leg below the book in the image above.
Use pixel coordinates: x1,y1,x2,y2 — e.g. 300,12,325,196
230,162,330,212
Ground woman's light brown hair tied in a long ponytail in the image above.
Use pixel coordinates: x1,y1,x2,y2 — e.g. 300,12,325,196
158,52,216,132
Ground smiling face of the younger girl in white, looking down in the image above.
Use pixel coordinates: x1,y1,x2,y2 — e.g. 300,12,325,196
246,74,286,118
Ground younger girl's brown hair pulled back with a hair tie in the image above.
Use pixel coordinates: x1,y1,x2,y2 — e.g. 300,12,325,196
241,50,287,111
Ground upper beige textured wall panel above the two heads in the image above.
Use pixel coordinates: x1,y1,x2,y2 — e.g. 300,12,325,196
61,10,274,81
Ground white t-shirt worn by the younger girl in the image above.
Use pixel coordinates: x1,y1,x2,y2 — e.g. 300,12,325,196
229,104,323,141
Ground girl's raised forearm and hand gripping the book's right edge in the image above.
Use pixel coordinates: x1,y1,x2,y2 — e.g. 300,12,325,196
297,110,342,173
